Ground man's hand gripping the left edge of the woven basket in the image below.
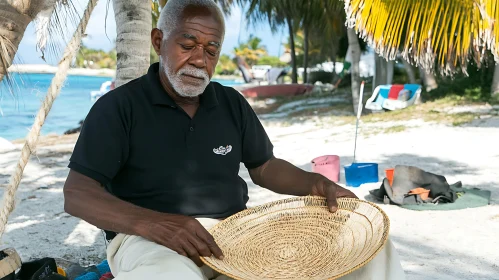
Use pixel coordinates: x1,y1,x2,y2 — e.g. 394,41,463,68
137,214,223,266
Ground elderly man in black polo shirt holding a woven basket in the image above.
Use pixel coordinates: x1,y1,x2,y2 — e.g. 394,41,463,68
64,0,403,280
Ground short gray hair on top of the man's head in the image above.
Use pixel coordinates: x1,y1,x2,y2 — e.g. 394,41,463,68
157,0,225,40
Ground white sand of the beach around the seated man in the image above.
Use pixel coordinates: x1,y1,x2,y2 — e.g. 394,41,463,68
0,112,499,280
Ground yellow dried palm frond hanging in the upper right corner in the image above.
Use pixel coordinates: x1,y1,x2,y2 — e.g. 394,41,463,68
345,0,499,75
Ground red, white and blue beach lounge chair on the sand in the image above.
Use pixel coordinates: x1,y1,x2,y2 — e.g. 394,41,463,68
365,84,421,111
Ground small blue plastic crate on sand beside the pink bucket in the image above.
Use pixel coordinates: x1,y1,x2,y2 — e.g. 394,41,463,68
345,162,379,187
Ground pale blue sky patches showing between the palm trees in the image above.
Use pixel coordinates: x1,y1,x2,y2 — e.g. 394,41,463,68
14,0,287,65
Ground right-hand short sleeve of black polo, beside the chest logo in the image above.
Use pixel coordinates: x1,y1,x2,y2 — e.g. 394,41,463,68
241,96,274,169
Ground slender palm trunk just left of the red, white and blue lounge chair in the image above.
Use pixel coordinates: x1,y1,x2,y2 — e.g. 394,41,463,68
347,28,363,114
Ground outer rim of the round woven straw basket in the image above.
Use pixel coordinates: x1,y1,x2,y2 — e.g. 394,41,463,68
201,196,390,280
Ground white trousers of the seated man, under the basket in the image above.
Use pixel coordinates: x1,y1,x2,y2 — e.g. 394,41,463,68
107,218,405,280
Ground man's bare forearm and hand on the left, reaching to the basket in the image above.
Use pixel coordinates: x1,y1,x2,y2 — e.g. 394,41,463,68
64,170,223,266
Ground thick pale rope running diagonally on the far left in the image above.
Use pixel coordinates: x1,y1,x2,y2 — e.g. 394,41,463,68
0,0,98,238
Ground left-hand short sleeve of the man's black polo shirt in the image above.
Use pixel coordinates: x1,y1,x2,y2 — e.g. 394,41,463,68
69,92,130,185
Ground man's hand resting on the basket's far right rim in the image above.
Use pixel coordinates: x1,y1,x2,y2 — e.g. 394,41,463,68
311,175,358,213
